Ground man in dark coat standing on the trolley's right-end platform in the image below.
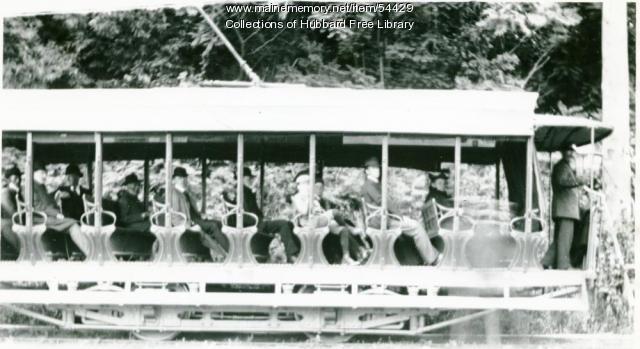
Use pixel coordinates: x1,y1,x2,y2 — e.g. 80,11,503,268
542,147,583,269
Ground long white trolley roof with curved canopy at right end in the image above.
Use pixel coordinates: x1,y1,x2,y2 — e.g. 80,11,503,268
0,87,611,144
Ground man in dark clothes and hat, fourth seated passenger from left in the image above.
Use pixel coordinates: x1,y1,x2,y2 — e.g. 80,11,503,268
118,173,151,232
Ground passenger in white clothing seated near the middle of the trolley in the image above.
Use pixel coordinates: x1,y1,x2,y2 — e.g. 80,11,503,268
291,171,368,265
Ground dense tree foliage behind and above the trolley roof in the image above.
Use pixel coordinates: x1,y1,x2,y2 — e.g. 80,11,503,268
4,3,601,114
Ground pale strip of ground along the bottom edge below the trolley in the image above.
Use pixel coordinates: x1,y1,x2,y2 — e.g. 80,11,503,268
0,332,635,349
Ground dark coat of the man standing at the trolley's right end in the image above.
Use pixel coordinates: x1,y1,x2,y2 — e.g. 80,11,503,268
551,160,581,220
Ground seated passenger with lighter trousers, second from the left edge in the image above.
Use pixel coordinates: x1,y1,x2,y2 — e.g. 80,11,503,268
33,163,91,256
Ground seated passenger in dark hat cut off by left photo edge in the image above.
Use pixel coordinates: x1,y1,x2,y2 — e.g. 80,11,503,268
0,165,22,252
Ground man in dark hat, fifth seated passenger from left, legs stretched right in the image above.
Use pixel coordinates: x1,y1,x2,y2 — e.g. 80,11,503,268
171,166,229,254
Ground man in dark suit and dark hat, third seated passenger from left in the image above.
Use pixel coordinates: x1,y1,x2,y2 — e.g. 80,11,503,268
55,164,91,220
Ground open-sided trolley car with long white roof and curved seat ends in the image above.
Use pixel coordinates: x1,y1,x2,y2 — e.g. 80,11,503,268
0,87,611,339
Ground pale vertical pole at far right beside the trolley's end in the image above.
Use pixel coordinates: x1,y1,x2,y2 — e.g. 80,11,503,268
602,1,631,223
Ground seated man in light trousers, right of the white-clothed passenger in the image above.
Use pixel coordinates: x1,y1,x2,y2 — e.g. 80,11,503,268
361,157,438,265
